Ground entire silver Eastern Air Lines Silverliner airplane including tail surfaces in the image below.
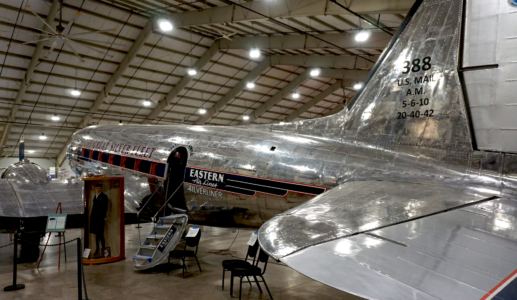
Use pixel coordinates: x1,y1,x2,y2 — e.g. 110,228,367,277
68,0,517,299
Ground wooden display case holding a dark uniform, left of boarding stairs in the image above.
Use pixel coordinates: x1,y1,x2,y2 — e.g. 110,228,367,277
82,177,125,264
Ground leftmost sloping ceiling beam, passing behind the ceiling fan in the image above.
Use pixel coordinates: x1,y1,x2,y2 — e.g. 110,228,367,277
0,0,59,155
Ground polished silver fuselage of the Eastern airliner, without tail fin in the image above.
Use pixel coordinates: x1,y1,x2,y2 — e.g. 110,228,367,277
69,119,515,226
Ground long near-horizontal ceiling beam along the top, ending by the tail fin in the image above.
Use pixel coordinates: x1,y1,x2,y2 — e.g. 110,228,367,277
169,0,415,27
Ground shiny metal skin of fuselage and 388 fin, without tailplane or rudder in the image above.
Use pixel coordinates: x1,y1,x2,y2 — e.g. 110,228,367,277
64,1,516,232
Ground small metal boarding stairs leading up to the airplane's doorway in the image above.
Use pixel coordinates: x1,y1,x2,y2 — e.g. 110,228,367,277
133,184,188,270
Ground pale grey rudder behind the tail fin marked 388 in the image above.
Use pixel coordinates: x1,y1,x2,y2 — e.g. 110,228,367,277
463,0,517,153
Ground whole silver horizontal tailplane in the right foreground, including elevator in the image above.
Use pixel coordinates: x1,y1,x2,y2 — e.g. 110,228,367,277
259,181,517,299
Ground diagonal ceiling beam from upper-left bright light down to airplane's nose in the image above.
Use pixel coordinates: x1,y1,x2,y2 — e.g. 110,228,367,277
78,19,154,127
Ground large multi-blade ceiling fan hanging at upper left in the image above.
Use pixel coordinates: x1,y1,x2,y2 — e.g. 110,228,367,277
23,0,125,62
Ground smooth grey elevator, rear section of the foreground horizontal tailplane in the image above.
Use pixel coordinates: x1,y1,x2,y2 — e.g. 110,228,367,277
282,197,517,300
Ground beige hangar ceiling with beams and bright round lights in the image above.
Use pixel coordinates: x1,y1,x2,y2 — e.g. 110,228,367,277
0,0,414,164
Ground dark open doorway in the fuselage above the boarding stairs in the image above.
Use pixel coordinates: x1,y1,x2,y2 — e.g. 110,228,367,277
164,147,188,213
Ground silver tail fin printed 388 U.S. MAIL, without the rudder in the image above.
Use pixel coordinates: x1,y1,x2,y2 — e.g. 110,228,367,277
343,0,472,156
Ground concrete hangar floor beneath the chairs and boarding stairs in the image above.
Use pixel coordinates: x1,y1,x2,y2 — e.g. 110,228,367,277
0,224,361,300
